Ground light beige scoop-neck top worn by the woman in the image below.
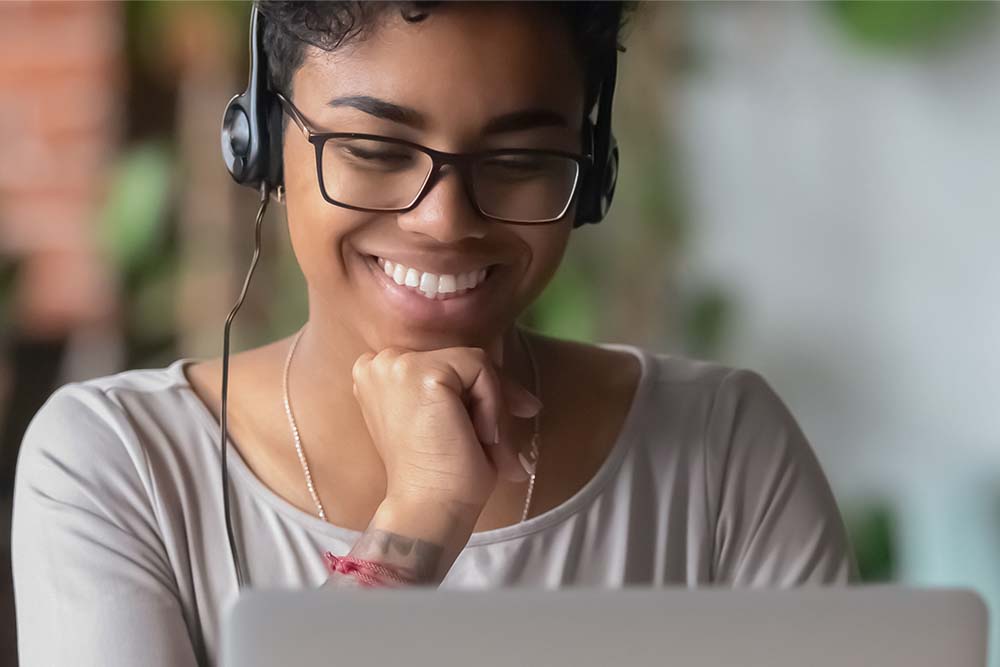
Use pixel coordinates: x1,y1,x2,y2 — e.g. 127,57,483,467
12,344,856,667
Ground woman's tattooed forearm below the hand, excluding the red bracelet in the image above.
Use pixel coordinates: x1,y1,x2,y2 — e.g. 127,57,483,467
324,499,478,588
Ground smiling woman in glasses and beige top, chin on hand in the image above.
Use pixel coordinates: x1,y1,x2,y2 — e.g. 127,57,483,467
13,3,854,665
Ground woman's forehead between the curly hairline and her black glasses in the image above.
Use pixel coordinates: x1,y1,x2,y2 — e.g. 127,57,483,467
292,3,584,137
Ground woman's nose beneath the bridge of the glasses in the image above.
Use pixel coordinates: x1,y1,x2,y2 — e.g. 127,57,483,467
397,165,490,243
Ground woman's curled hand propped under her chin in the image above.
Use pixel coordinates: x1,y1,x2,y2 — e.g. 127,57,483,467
352,338,541,521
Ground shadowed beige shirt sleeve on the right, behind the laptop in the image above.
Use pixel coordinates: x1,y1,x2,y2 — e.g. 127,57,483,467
706,369,858,588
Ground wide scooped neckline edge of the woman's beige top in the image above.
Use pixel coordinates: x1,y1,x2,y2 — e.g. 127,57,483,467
167,343,654,547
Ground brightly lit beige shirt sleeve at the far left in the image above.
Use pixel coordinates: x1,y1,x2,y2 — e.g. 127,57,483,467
11,384,197,667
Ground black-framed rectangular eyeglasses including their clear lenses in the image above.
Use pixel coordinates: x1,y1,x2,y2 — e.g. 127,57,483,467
276,93,592,225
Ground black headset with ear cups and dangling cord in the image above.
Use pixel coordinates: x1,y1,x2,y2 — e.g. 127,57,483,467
219,3,624,590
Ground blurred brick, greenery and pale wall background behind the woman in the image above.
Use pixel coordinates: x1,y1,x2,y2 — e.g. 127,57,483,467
0,2,1000,667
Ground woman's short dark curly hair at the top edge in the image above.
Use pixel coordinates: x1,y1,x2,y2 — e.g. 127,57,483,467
257,0,638,113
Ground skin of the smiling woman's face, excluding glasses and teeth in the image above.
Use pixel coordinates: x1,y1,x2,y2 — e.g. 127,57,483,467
284,3,583,350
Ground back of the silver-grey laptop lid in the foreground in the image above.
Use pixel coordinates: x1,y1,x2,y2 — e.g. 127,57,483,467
221,586,987,667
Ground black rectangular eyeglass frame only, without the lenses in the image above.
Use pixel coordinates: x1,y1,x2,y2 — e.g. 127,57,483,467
274,93,594,225
